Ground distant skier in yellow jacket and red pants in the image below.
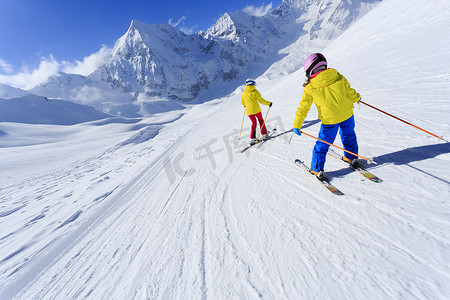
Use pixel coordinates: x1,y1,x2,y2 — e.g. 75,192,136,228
241,78,272,144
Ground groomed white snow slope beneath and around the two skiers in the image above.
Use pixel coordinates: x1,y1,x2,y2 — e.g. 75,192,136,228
0,0,450,299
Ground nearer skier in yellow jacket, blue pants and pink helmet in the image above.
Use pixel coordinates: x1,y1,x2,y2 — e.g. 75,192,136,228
294,53,361,180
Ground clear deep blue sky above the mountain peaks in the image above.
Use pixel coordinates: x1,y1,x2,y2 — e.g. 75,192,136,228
0,0,282,88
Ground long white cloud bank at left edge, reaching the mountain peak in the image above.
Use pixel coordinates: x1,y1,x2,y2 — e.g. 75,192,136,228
0,46,111,90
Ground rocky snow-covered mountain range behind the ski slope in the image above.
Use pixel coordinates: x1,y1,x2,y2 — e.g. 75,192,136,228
29,0,379,116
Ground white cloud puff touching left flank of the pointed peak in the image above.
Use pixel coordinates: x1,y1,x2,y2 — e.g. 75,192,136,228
62,46,111,76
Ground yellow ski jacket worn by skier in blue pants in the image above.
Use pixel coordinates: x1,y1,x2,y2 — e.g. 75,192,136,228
294,69,361,128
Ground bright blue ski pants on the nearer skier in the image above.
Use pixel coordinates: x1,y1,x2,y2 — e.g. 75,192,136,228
311,116,358,172
